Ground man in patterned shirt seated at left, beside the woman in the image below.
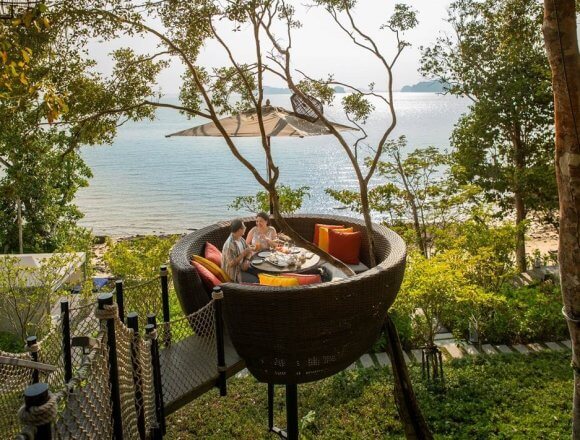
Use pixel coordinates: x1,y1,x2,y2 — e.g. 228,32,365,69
222,219,258,283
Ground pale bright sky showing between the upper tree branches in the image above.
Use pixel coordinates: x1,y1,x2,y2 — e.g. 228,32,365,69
92,0,450,94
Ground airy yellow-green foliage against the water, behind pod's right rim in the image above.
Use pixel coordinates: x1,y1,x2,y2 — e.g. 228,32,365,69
326,136,479,257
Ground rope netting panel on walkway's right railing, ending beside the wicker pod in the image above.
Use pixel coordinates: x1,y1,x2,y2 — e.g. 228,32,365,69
159,300,218,405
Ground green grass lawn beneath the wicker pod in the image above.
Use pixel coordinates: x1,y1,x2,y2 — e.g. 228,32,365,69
166,352,573,440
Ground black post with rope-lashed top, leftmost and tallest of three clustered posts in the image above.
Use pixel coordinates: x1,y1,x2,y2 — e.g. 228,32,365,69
97,293,123,440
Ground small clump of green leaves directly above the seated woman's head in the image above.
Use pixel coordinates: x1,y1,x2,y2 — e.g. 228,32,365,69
228,185,310,214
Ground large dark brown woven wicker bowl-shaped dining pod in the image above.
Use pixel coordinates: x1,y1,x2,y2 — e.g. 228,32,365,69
171,215,406,384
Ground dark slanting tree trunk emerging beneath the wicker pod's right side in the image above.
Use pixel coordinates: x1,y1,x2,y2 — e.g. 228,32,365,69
384,314,433,440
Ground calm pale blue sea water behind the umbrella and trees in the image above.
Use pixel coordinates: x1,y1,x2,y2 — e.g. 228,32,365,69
77,93,468,236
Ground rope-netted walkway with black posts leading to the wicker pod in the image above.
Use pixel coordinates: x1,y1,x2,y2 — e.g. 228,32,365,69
0,268,244,439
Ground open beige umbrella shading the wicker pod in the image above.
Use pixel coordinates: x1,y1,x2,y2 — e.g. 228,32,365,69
166,95,358,214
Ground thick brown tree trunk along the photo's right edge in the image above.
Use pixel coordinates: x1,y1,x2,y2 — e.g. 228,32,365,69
543,0,580,439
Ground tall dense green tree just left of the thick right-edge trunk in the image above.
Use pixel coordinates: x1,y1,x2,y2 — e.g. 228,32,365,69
421,0,558,271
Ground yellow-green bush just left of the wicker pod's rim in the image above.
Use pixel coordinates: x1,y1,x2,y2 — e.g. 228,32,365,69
103,235,179,280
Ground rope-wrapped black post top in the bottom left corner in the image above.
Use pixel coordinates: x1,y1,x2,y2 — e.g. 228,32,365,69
18,383,57,440
